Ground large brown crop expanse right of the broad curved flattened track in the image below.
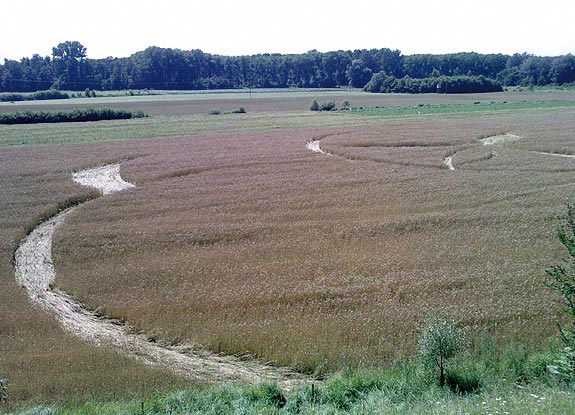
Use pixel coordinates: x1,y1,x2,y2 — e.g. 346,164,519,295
55,106,575,371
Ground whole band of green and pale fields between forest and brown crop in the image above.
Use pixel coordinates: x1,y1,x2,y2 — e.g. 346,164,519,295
0,90,575,146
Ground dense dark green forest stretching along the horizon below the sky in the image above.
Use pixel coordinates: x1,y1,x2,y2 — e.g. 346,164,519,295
0,41,575,92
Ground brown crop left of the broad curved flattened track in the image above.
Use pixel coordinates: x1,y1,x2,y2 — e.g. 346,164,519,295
0,146,189,402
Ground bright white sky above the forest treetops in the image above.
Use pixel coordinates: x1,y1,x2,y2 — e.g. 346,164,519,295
0,0,575,62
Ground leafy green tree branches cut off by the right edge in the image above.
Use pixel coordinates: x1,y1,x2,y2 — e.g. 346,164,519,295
545,202,575,380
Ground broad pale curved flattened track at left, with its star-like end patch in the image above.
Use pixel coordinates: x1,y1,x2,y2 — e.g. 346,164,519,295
15,164,311,390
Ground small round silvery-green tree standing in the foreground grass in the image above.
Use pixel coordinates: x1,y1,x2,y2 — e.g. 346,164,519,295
418,315,465,387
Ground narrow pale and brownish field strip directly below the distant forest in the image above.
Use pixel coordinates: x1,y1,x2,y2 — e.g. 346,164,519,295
0,89,575,115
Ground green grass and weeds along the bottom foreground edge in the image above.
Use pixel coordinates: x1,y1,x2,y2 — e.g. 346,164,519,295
7,348,575,415
